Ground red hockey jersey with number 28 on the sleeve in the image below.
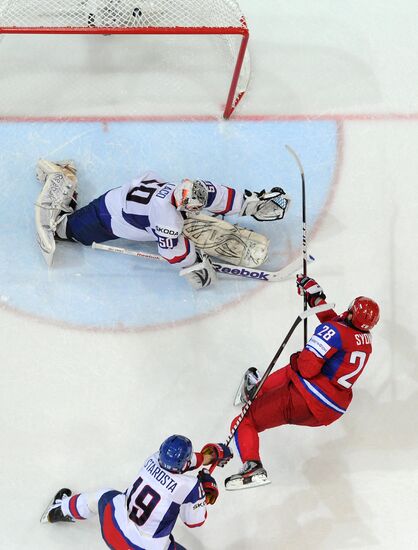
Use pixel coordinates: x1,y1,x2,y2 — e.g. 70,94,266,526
291,309,372,425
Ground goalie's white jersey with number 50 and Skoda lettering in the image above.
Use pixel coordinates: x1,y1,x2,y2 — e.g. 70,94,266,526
105,172,243,267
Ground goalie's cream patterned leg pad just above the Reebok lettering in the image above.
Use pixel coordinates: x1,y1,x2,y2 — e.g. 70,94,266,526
183,214,269,267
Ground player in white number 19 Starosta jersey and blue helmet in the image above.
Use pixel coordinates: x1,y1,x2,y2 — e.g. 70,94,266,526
41,435,232,550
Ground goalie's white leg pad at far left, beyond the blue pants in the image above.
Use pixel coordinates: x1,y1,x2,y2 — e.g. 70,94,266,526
35,159,77,266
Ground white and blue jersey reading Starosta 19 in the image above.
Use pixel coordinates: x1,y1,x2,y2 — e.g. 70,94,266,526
116,453,207,550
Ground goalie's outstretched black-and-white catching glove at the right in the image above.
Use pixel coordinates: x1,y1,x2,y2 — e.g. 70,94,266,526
240,187,290,222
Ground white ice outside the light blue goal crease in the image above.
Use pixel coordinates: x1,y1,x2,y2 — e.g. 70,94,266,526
0,0,418,550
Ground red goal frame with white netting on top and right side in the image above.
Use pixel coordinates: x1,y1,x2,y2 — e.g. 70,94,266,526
0,0,250,118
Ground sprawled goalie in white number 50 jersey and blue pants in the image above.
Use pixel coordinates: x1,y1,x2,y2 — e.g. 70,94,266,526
35,159,289,289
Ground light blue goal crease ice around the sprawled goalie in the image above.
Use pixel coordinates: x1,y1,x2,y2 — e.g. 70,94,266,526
0,118,342,330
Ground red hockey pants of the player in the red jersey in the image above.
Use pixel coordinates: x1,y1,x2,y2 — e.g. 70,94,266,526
231,366,322,462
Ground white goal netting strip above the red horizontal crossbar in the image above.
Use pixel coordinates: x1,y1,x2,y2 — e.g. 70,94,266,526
0,0,245,29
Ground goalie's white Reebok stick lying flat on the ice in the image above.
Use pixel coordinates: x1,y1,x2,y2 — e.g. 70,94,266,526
91,242,315,282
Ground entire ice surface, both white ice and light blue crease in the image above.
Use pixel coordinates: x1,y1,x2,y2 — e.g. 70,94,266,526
0,0,418,550
